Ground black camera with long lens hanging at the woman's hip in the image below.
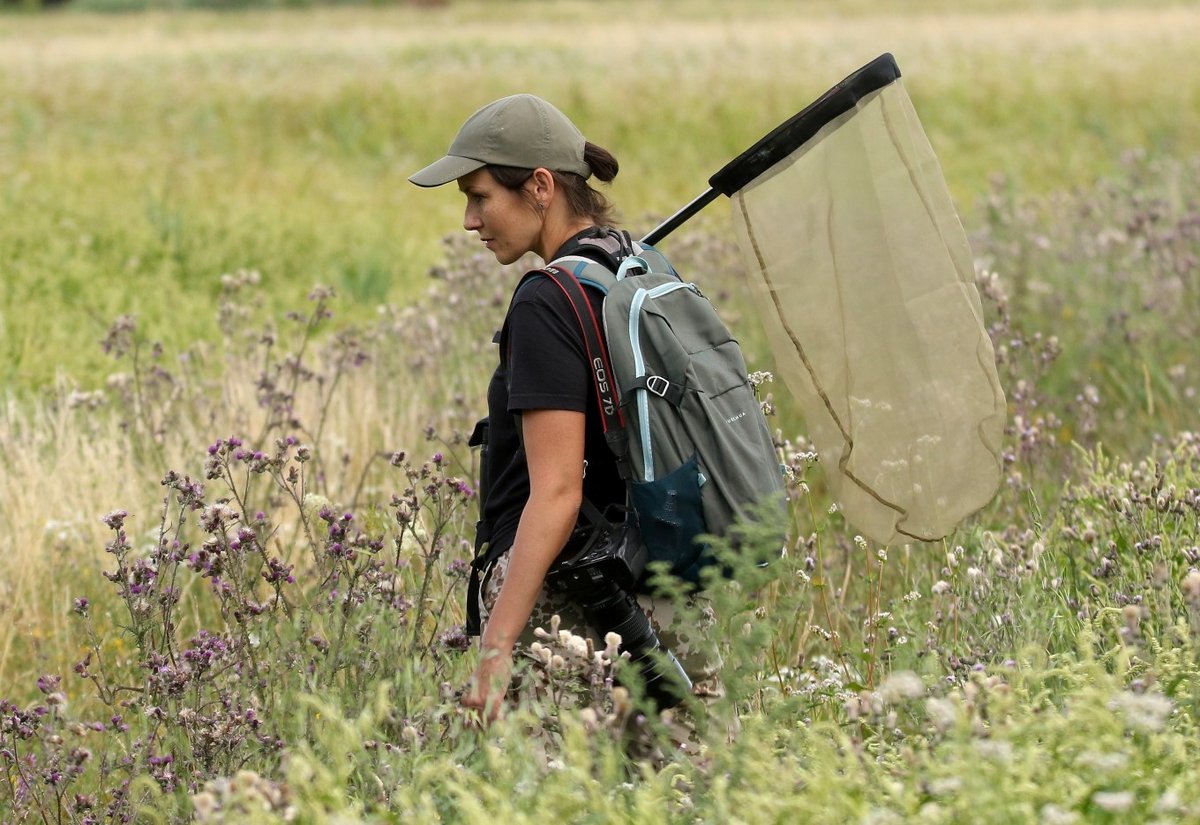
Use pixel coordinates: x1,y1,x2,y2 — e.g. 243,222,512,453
546,523,691,710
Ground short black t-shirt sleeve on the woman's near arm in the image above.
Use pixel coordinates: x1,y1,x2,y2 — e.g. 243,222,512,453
508,281,590,413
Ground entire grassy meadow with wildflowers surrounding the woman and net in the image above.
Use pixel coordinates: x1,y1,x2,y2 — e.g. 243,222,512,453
0,0,1200,823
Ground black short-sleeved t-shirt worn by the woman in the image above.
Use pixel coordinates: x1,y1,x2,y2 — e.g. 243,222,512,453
482,229,625,558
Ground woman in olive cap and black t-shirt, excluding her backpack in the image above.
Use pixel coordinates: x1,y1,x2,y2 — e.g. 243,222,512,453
409,95,638,721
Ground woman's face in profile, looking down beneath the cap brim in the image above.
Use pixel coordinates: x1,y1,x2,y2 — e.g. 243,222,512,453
458,169,542,264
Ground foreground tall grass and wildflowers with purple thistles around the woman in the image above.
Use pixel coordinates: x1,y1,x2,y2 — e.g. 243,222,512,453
0,146,1200,823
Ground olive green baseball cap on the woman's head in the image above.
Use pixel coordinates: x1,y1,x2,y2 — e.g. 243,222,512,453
408,95,592,186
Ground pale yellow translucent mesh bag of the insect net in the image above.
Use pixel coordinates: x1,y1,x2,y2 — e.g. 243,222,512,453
731,78,1006,544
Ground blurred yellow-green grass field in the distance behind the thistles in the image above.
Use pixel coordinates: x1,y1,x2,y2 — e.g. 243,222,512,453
0,2,1200,390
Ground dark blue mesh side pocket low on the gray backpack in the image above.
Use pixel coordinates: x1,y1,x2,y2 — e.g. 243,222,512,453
630,456,708,580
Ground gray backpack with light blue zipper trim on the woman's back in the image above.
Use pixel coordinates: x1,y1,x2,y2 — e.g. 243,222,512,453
527,231,784,583
